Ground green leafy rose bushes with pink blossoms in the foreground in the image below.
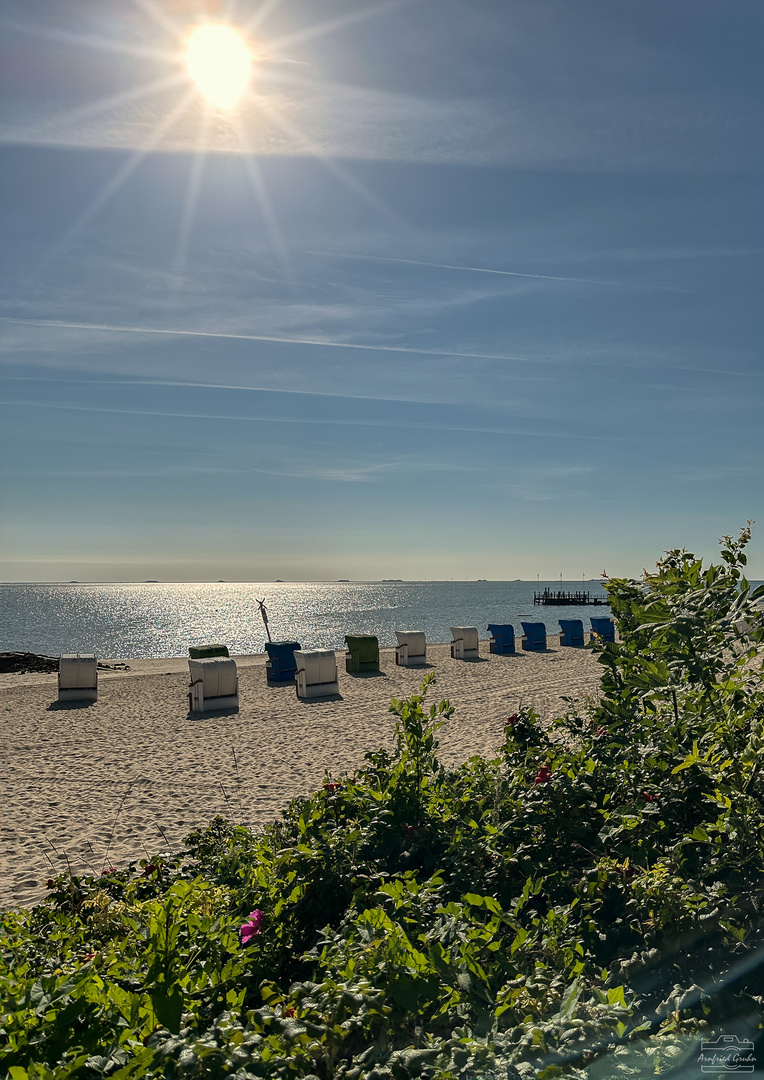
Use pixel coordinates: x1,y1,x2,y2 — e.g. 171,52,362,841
0,529,764,1080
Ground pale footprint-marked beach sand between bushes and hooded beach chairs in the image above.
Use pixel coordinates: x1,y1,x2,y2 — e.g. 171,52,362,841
0,638,602,907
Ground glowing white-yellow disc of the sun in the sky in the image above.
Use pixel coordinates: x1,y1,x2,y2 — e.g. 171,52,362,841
186,25,252,109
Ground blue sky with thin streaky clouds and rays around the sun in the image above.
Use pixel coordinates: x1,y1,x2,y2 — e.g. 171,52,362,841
0,0,764,581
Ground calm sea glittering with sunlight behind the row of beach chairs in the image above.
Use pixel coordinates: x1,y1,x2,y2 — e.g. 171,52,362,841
0,581,609,658
